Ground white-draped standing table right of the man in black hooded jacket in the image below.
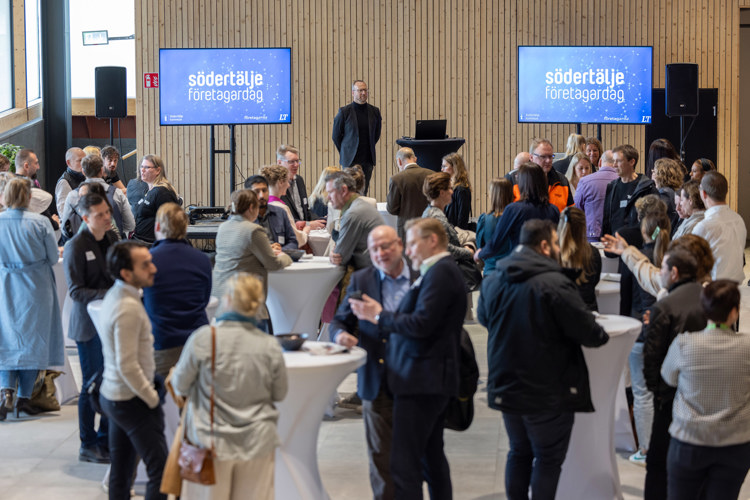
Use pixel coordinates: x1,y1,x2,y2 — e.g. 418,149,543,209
555,315,641,500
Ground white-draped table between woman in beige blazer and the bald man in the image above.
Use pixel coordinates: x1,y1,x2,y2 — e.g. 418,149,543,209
266,257,344,338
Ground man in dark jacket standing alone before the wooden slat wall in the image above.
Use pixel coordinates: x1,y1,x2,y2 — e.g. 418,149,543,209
332,80,383,196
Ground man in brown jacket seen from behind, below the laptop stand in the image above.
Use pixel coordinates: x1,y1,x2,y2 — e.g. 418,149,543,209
386,148,434,240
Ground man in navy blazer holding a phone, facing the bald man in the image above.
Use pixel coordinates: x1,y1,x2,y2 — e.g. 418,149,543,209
349,218,466,499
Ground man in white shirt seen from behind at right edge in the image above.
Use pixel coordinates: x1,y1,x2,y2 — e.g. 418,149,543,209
693,172,747,283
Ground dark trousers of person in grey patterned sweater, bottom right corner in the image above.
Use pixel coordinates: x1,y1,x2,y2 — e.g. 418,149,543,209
667,438,750,500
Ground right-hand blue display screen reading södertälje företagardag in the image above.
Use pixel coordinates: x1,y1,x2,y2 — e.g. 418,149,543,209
518,46,653,124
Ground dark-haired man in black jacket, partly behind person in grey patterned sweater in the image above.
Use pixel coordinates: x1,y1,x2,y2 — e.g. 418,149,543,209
643,248,706,500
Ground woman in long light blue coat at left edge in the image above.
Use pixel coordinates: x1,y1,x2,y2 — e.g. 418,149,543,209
0,178,64,420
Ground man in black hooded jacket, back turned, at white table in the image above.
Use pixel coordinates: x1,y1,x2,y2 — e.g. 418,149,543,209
477,219,609,498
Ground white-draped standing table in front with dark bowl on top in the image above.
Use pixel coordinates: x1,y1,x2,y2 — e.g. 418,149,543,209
275,347,367,500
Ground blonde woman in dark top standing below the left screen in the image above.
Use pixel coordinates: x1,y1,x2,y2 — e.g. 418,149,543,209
132,155,179,244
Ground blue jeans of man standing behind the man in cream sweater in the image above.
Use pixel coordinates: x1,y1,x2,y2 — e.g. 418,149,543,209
76,335,109,449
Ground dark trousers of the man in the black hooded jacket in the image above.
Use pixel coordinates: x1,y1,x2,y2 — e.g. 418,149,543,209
503,413,575,500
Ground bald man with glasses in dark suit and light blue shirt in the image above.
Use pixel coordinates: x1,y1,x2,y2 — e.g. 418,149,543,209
331,226,412,500
